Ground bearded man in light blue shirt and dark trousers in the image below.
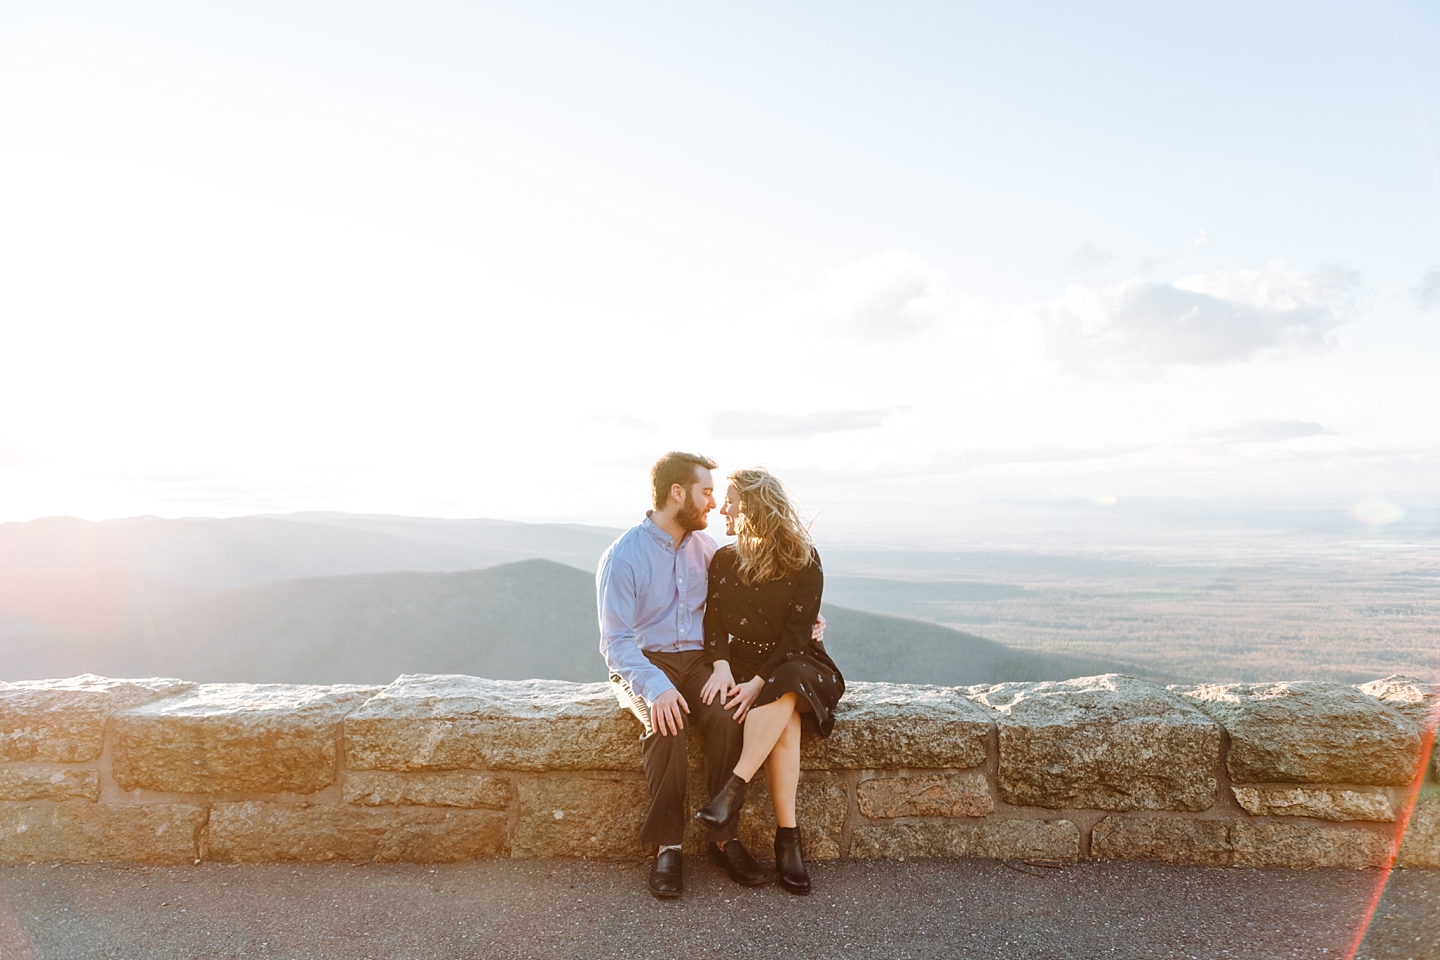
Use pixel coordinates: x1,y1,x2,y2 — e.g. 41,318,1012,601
595,450,770,900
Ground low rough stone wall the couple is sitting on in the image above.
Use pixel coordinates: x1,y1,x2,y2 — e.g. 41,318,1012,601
0,675,1440,868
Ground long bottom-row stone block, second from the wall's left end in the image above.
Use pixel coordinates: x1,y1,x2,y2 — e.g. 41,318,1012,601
204,800,508,864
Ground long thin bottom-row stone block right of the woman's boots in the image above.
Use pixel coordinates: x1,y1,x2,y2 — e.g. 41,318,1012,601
850,819,1080,861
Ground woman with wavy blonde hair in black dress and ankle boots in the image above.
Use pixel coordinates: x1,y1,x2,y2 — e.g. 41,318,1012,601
696,469,845,894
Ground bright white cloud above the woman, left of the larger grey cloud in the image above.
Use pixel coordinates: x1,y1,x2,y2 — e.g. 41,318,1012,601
779,250,945,340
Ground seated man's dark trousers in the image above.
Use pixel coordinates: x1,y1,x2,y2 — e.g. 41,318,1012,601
611,651,744,846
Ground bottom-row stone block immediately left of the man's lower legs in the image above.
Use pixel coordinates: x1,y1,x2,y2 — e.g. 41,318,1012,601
510,777,654,859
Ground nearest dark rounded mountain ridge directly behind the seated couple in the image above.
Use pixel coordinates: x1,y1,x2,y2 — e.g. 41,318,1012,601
0,560,1146,684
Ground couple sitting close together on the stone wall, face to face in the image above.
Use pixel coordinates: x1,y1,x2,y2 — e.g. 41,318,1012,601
596,452,845,898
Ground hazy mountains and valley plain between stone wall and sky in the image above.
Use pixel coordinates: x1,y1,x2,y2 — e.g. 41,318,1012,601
0,514,1440,684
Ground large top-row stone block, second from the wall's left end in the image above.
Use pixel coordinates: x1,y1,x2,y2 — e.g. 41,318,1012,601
112,684,377,793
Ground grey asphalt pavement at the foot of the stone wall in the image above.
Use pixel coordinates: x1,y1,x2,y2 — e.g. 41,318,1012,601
0,859,1440,960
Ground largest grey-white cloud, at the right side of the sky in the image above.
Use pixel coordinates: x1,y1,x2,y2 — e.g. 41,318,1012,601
1037,261,1359,380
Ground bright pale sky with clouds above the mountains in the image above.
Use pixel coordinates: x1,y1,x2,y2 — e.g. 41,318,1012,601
0,0,1440,522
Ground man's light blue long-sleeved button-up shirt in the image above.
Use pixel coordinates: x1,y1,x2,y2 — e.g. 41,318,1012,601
595,514,716,704
